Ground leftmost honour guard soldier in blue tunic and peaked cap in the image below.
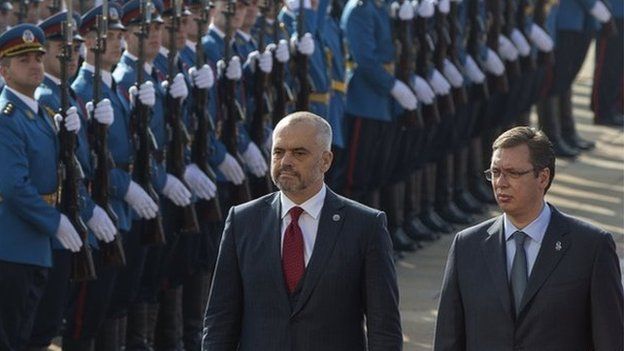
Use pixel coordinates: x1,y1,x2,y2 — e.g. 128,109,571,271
0,24,83,350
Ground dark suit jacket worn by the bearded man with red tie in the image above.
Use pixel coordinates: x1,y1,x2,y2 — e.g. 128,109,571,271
203,189,402,351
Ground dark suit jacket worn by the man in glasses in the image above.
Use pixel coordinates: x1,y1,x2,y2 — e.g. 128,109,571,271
435,206,624,351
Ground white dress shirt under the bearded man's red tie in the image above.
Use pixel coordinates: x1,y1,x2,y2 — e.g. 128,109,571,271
280,184,327,267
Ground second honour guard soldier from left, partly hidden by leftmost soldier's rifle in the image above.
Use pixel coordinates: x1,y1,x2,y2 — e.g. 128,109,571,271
30,11,117,350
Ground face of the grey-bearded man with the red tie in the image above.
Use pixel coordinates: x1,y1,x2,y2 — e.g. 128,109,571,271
271,122,333,200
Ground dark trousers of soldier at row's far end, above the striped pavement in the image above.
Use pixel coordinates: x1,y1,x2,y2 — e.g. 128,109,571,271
549,30,593,96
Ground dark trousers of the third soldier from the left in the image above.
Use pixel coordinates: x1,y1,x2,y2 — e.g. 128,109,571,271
63,250,120,340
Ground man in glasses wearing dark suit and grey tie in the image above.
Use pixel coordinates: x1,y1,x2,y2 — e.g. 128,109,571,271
435,127,624,351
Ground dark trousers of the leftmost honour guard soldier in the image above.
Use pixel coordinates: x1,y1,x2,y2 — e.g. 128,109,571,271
0,261,49,351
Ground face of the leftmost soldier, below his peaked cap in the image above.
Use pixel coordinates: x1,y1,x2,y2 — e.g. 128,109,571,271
0,52,44,96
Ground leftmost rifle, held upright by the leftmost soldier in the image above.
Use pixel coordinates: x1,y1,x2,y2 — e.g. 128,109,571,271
58,0,96,281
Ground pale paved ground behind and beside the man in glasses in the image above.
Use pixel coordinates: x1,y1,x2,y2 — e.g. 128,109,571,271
398,47,624,351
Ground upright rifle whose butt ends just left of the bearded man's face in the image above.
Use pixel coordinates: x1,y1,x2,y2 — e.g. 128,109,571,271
249,0,273,197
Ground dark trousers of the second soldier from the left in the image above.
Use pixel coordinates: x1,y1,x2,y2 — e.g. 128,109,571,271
28,249,71,347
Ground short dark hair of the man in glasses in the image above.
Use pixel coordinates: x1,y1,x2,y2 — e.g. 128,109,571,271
492,127,555,194
